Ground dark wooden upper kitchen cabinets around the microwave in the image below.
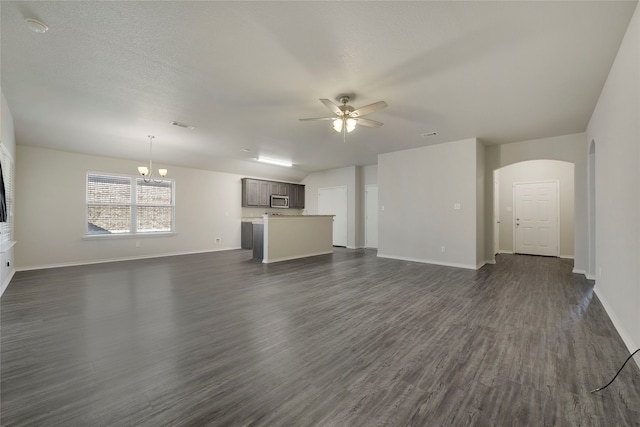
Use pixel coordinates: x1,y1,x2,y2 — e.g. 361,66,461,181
242,178,304,209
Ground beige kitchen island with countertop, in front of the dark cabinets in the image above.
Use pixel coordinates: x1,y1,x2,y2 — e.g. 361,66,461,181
253,214,333,264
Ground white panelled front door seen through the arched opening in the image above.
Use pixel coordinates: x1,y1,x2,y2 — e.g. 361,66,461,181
513,181,559,256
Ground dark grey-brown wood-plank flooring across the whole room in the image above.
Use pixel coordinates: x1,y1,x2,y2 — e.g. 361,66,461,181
0,249,640,426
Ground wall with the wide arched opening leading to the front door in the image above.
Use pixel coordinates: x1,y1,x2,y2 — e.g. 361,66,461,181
485,133,589,273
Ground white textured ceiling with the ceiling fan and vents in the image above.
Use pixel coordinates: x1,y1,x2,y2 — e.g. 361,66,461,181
0,1,637,181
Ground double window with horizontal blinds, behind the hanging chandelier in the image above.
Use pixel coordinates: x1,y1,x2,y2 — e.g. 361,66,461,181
87,173,175,236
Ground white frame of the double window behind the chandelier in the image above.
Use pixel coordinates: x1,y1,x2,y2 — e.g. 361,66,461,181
83,171,176,239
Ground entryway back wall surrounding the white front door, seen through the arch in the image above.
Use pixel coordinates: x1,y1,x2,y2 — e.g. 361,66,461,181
498,160,574,258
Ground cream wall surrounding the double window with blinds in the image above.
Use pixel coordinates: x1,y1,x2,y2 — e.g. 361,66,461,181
15,145,250,269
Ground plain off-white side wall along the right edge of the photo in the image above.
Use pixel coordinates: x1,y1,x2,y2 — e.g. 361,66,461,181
583,3,640,362
